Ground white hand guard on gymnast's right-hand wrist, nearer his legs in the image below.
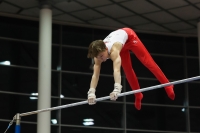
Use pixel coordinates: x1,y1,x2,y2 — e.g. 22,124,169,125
110,83,122,101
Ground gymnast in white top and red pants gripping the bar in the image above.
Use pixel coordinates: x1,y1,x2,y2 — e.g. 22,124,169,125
87,28,175,110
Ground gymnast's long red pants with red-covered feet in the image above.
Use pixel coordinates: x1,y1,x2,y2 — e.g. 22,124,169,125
120,28,175,110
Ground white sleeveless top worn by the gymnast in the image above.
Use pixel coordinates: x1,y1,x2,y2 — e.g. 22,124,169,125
103,29,128,54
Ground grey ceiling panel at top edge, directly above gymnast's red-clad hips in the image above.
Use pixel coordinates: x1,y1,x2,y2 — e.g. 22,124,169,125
121,0,160,13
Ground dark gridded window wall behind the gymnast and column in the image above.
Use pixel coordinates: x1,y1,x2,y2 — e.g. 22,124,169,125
0,17,200,133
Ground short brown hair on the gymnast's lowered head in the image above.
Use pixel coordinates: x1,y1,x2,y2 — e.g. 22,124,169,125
87,40,106,58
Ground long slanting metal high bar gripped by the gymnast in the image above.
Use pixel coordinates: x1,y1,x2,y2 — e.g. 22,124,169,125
20,76,200,116
